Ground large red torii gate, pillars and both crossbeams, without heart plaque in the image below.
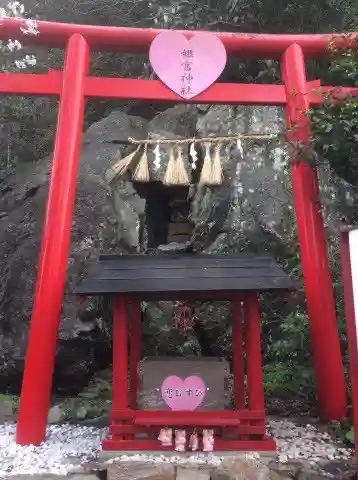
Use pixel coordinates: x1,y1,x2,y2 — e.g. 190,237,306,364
0,18,358,445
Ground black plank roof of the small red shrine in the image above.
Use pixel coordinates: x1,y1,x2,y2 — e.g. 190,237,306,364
75,253,295,299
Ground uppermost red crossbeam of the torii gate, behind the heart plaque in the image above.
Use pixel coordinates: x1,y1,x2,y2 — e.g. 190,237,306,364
0,18,358,59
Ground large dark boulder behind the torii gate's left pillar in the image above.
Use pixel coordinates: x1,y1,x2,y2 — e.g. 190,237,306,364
0,111,148,394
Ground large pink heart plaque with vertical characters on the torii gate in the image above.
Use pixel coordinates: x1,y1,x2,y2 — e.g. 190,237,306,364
149,31,227,99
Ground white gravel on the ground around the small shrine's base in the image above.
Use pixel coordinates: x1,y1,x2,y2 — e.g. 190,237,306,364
0,420,353,478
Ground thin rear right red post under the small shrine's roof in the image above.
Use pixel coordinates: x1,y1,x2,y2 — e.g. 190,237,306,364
231,297,245,410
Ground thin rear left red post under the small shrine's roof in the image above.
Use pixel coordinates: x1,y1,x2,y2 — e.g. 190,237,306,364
130,298,142,410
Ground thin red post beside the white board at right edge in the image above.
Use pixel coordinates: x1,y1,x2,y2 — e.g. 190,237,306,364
340,227,358,468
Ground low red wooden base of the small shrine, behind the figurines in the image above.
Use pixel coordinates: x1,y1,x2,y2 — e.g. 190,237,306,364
103,409,276,451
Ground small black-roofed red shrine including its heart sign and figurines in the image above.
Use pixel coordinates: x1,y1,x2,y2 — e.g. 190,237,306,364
76,254,295,452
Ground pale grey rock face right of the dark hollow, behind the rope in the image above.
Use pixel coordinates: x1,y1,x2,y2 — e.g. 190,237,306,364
191,106,288,253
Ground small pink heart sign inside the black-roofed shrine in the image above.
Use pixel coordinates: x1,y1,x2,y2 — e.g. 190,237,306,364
160,375,206,410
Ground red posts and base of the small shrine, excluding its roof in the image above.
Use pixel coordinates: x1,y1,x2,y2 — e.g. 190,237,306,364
103,293,276,451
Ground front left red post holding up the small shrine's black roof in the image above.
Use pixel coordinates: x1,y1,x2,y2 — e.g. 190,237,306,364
112,295,128,410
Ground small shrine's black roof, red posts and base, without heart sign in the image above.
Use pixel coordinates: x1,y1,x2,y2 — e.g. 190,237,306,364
76,254,295,451
